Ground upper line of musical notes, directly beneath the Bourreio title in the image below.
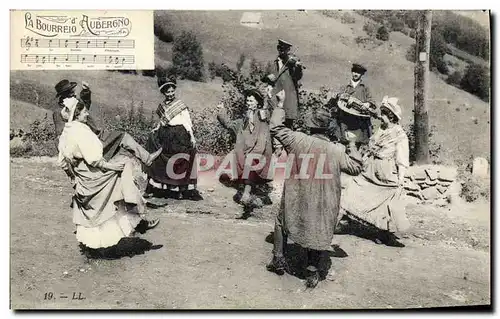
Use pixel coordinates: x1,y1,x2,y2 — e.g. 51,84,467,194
21,37,135,49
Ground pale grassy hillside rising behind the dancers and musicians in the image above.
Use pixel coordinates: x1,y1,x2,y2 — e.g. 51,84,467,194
11,11,490,162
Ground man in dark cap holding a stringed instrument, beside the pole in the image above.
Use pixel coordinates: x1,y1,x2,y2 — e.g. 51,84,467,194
333,63,377,148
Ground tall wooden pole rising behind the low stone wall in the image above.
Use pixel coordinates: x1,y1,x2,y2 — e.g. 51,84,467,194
414,10,432,164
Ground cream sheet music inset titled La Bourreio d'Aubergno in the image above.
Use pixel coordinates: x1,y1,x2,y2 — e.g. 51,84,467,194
11,10,154,70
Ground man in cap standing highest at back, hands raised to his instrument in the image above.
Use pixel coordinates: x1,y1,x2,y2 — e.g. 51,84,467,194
273,39,302,128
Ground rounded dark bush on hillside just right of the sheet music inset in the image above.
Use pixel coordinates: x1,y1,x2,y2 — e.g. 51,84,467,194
172,31,204,81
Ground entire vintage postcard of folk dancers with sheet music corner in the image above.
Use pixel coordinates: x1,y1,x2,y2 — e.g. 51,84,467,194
10,9,492,310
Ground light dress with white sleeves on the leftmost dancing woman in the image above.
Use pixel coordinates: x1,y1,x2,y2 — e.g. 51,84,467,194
59,121,144,249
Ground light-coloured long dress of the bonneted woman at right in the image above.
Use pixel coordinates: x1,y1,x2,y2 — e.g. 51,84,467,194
341,125,410,231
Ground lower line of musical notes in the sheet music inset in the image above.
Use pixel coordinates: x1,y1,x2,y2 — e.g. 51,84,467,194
21,54,135,65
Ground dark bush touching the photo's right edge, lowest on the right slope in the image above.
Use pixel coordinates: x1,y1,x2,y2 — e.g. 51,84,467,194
460,64,490,101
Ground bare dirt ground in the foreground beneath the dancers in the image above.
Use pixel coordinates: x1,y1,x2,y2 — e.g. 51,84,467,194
10,159,490,309
